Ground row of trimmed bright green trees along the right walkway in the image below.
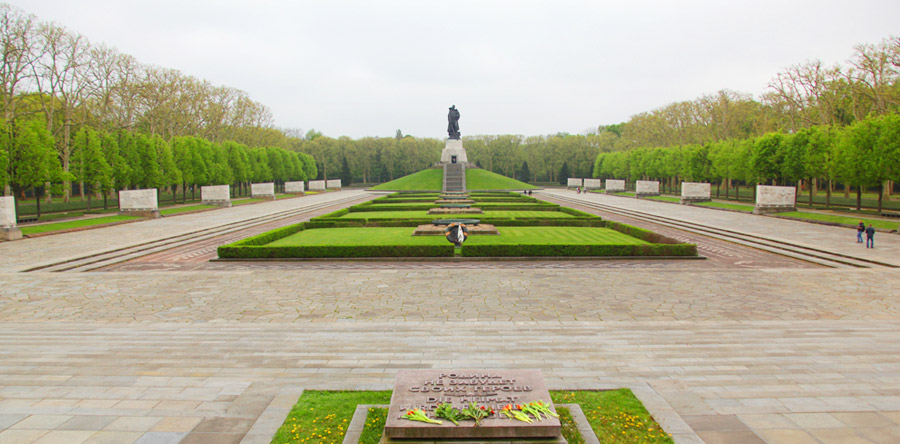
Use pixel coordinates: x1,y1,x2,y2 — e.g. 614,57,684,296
593,114,900,211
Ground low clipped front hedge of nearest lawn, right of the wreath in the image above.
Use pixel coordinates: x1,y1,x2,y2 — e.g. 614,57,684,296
462,244,697,257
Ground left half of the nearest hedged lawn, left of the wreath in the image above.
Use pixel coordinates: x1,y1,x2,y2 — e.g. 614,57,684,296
266,227,447,247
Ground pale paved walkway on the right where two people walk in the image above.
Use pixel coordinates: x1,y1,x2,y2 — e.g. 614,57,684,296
536,190,900,266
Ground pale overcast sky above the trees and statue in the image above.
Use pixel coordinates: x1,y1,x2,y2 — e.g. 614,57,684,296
8,0,900,138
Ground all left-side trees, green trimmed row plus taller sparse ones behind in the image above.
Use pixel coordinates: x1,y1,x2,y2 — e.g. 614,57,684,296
0,4,308,206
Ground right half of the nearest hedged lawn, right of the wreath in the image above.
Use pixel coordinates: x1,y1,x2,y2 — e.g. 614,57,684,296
463,227,649,248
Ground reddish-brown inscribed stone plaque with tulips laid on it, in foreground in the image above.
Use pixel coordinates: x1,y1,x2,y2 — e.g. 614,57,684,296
384,370,560,439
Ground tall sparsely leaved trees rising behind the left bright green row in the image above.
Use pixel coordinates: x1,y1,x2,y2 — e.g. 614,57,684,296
0,4,304,200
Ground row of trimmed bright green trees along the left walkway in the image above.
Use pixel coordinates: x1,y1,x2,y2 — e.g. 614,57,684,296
0,115,317,213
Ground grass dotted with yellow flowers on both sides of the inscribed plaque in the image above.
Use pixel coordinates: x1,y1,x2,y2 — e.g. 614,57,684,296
272,389,673,444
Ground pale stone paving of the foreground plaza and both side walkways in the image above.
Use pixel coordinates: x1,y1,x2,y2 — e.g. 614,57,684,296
0,190,900,444
